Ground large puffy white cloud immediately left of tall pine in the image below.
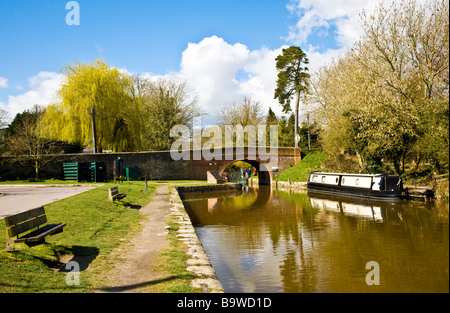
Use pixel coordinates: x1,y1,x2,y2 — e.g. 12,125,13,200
178,36,281,122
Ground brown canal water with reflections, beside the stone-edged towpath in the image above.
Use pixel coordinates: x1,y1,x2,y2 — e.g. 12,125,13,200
182,186,449,293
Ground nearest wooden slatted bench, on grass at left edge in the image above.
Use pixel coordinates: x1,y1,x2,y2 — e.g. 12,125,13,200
5,207,66,251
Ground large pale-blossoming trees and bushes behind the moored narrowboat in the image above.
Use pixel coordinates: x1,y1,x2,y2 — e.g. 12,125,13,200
309,0,449,174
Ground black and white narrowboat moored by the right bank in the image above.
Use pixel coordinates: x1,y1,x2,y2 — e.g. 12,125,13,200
307,172,403,200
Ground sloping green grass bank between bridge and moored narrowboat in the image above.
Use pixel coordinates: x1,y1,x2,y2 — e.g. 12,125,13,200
275,151,328,182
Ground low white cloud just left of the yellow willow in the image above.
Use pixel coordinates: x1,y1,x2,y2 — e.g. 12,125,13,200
2,72,64,117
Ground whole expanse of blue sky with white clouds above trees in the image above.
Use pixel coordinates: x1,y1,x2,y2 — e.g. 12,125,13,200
0,0,380,123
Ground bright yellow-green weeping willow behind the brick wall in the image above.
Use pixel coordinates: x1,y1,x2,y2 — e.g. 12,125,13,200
46,60,142,152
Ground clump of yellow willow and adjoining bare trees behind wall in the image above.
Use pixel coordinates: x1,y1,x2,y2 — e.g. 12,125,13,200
45,60,200,152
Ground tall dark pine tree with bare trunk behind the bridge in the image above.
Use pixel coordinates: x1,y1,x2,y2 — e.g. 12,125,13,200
274,46,310,148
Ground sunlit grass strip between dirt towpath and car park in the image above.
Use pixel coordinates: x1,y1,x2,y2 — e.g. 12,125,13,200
0,182,156,293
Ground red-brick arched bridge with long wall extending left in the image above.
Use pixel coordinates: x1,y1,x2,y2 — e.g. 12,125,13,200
1,147,301,184
